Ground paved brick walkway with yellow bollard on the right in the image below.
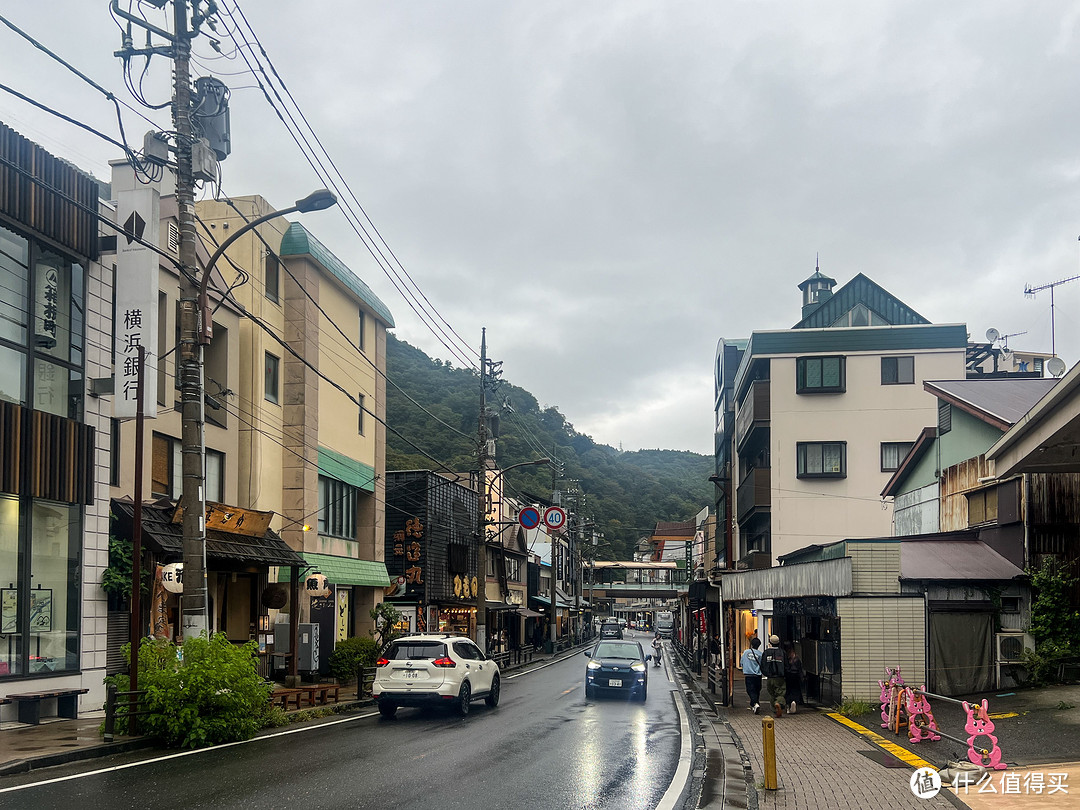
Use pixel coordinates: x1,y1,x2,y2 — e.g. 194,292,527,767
719,707,953,810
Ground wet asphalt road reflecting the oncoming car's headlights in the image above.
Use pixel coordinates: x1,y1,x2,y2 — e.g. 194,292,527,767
0,636,689,810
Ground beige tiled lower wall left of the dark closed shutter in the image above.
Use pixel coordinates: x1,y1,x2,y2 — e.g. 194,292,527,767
836,596,927,703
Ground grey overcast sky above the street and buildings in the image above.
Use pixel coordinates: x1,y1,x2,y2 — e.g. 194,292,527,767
0,0,1080,453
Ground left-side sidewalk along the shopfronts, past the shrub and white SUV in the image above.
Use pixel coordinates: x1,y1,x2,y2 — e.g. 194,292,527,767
0,644,588,778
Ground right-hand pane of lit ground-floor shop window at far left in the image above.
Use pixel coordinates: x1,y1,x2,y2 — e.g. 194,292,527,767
24,500,82,673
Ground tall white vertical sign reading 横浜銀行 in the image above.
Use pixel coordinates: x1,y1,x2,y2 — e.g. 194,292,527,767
112,187,161,419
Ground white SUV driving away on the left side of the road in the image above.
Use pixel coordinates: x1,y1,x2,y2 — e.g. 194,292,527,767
372,634,500,717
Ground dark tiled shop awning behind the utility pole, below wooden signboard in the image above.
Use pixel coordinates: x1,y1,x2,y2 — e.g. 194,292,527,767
111,498,305,565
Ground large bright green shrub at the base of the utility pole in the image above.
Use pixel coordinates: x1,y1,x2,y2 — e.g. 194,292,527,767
106,633,270,748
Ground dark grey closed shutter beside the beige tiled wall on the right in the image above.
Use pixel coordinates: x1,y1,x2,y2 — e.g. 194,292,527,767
929,611,994,696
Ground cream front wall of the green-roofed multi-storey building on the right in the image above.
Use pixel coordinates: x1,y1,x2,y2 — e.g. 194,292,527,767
770,350,964,559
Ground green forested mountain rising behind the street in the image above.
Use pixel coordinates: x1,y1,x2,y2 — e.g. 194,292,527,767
387,334,715,559
